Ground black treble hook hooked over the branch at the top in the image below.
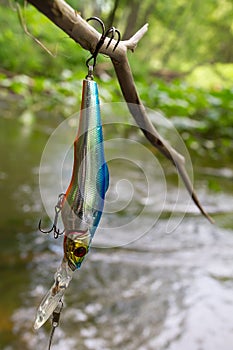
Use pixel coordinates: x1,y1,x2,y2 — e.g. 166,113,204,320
86,16,121,69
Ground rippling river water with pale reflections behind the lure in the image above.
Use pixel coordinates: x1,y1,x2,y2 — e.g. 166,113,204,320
0,108,233,350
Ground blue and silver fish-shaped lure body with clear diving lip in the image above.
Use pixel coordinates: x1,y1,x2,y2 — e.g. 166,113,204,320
34,78,109,329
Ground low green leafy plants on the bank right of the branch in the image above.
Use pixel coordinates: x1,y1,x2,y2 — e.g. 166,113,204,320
140,80,233,156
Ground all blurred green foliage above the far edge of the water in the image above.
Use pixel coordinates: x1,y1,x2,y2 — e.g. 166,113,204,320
0,0,233,163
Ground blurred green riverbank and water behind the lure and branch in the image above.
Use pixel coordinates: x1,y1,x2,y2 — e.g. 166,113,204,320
0,0,233,350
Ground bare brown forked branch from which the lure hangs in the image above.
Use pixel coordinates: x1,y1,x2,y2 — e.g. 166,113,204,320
25,0,212,222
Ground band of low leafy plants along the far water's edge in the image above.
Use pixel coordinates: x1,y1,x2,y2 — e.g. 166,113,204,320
0,66,233,157
